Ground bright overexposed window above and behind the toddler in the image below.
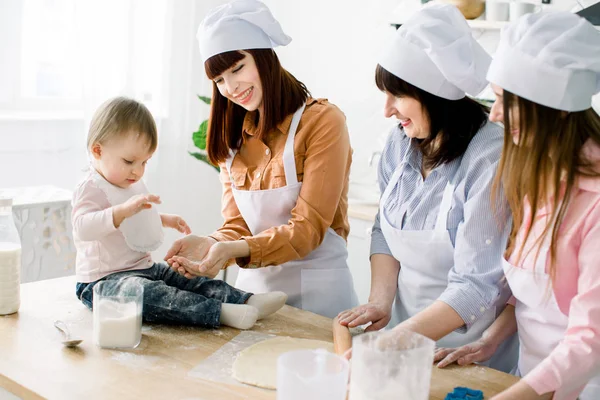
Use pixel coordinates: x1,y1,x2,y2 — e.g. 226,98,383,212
0,0,171,115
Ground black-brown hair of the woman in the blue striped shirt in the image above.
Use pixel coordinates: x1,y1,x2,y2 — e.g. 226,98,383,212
375,65,489,168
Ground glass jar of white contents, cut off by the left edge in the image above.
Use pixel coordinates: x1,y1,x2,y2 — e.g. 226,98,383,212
0,198,21,315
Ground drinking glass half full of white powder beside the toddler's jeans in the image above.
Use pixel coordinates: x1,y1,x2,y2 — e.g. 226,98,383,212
93,277,144,349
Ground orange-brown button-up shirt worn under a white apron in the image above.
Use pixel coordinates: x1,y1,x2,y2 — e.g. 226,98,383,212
211,98,352,267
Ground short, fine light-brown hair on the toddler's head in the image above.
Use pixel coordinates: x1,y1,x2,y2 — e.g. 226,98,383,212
87,97,158,153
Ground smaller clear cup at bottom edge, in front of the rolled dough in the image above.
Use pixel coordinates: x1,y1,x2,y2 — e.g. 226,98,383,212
277,349,349,400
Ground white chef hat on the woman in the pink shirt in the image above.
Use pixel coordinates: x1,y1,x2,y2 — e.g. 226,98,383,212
487,12,600,111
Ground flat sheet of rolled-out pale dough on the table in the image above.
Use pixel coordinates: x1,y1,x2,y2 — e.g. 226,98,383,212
232,336,333,389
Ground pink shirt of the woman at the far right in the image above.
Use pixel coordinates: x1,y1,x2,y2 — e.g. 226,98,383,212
509,142,600,398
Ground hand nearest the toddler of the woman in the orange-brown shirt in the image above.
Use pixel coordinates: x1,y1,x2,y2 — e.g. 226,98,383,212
165,235,217,279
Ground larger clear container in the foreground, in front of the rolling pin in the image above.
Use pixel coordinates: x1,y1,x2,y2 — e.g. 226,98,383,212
350,331,435,400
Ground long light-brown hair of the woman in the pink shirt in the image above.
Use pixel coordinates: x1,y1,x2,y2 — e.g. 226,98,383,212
493,90,600,282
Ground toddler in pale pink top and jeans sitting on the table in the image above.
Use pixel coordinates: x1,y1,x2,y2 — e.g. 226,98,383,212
72,97,287,329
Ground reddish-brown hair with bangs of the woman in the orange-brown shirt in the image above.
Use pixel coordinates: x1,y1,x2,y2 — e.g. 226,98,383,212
204,49,310,165
